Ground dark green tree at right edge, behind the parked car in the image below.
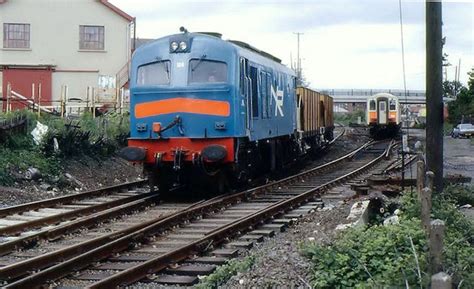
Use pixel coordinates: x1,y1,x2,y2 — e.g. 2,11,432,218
444,67,474,124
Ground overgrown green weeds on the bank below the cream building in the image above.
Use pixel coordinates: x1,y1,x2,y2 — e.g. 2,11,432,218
0,110,129,185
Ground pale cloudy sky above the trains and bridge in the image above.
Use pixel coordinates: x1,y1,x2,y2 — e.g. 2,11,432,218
109,0,474,90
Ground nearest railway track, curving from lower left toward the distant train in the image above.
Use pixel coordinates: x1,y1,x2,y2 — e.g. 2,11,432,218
0,137,393,288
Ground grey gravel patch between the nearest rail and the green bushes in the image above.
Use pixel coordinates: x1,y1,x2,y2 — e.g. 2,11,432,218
223,197,354,288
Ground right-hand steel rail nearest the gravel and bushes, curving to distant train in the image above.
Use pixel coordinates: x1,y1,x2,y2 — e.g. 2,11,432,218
88,139,391,288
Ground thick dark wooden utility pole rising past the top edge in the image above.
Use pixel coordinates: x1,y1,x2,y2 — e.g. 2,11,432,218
426,0,443,192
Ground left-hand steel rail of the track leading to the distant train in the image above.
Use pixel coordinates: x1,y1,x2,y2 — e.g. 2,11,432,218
5,139,382,288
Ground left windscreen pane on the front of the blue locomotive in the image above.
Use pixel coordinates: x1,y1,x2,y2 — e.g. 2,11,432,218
137,60,171,86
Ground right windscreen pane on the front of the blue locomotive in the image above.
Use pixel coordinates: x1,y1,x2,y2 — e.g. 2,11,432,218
188,59,227,83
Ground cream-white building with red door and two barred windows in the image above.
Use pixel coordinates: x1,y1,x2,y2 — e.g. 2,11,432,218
0,0,135,110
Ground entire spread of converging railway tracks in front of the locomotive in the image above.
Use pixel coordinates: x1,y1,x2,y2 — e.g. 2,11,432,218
0,134,396,288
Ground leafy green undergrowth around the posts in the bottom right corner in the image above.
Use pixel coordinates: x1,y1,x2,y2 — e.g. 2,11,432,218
301,187,474,288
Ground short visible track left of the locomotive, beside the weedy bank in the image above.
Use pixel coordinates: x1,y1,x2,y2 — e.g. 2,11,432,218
0,180,152,255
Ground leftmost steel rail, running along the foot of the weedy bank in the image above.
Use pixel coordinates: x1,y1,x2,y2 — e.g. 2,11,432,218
0,180,147,217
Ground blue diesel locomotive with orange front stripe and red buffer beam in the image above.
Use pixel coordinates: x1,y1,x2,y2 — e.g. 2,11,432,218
122,31,332,191
